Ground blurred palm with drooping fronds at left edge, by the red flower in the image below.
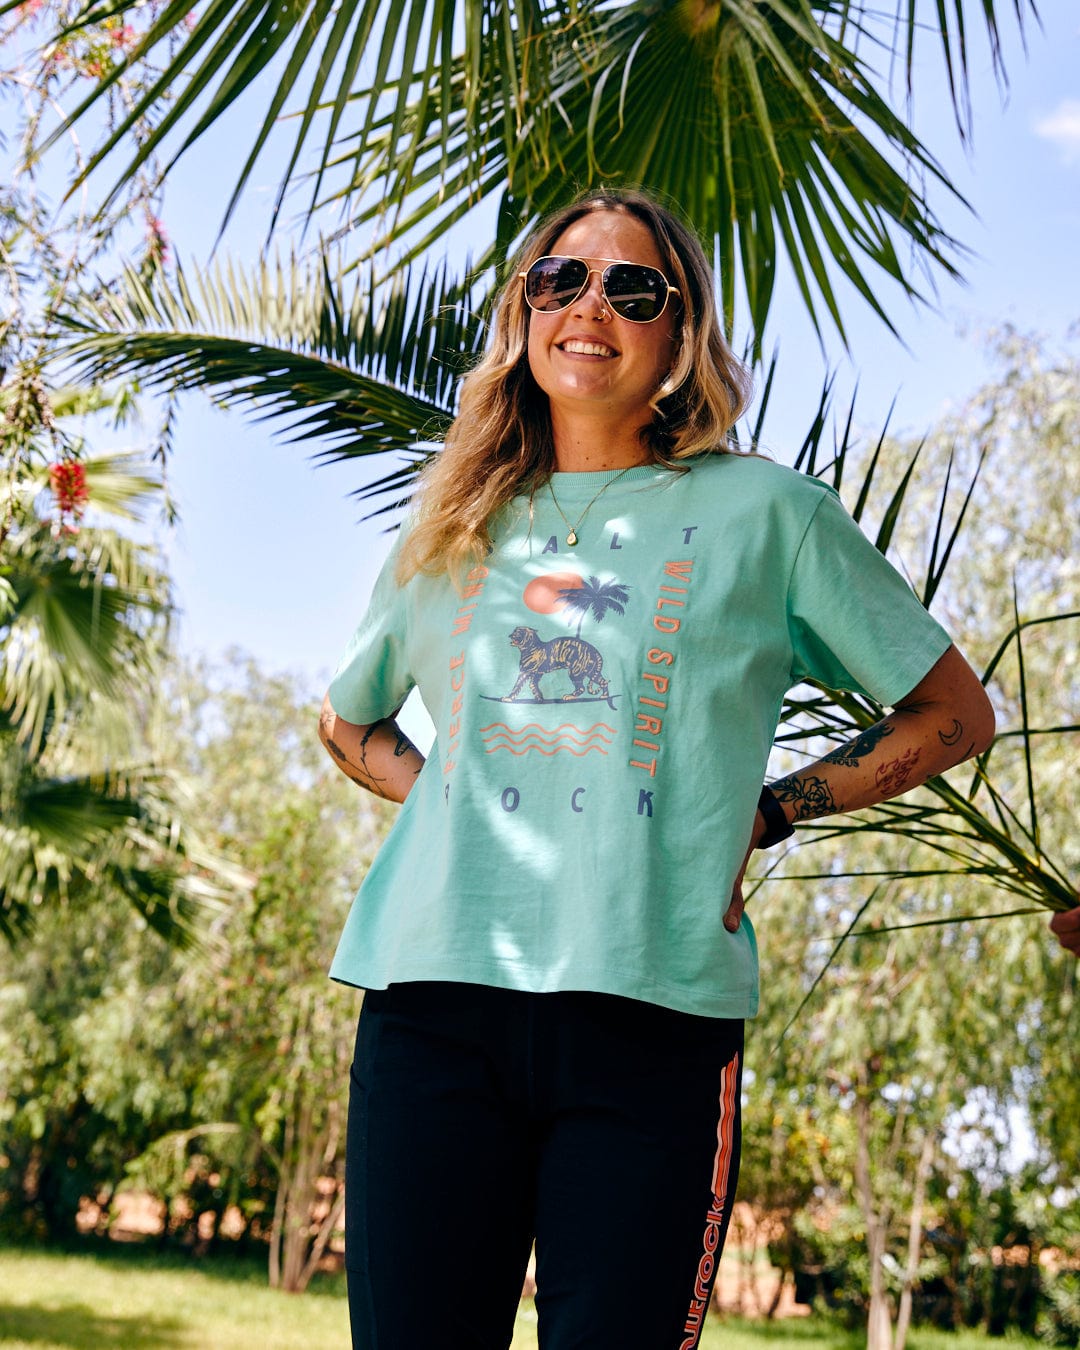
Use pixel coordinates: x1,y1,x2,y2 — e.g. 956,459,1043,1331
0,426,236,941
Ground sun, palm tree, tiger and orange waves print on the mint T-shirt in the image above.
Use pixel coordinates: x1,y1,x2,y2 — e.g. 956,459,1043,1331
481,572,630,756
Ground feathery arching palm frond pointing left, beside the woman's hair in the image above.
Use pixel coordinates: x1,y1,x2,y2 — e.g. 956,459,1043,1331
54,257,483,486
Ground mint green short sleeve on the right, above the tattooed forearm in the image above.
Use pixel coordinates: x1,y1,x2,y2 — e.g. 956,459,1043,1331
788,485,950,706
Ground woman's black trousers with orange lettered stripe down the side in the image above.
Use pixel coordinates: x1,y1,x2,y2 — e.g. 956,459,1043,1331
346,983,743,1350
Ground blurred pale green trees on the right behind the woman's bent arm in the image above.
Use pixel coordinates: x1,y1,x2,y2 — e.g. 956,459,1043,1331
744,332,1080,1350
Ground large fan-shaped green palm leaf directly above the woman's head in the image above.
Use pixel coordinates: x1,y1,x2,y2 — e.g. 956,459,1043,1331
327,0,959,345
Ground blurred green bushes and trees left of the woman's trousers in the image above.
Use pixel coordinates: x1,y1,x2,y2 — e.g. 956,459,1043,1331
0,659,386,1289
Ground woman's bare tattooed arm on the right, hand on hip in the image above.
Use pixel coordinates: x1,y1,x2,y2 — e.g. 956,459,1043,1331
724,647,994,932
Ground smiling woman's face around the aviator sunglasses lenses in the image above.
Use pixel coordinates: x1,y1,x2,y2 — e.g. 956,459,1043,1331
528,211,675,425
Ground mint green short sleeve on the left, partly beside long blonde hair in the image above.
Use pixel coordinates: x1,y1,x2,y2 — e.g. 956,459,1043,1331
329,531,414,726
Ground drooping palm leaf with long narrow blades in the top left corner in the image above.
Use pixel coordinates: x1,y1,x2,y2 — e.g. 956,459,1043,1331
25,0,574,237
